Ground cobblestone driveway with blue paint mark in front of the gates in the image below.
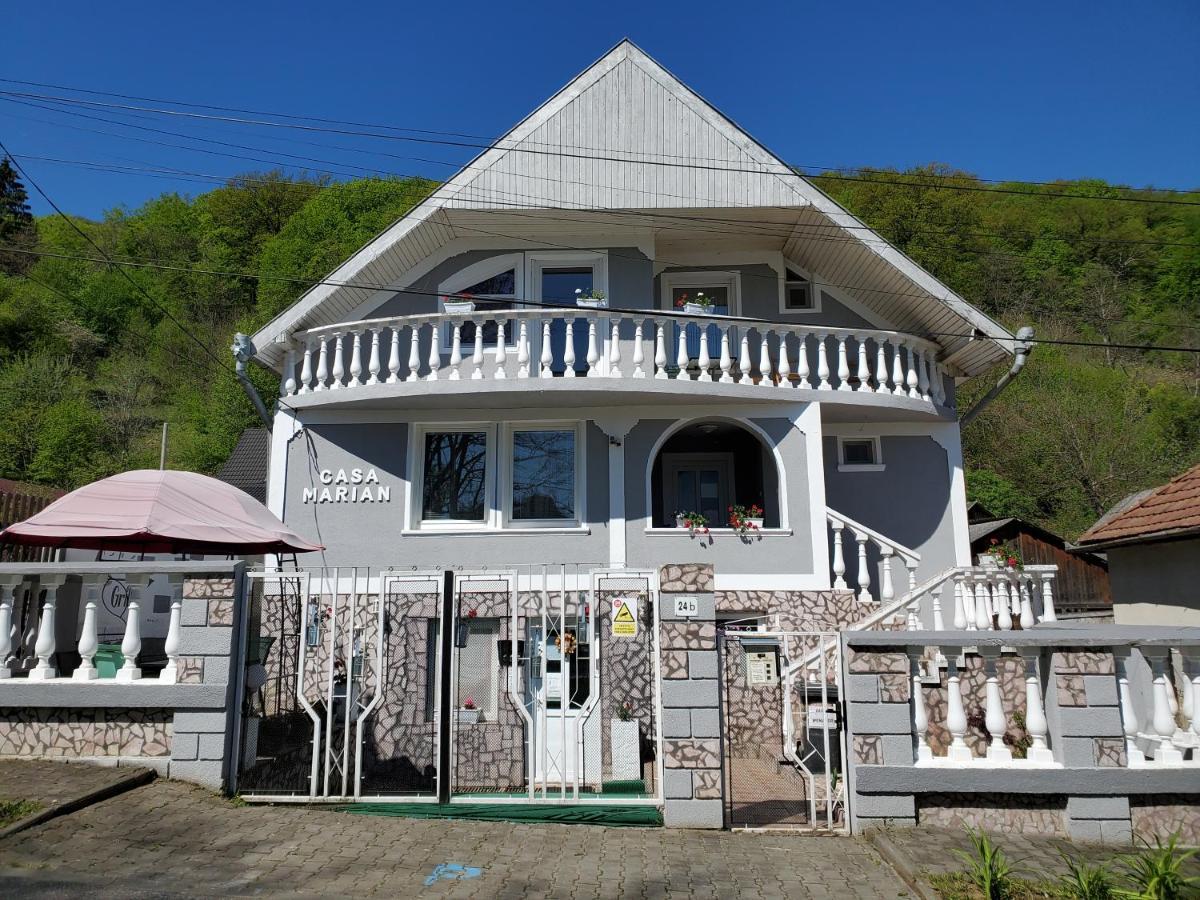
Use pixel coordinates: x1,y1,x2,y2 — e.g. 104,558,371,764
0,781,907,898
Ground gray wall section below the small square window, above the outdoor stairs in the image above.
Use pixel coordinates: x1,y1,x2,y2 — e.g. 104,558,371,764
822,434,956,592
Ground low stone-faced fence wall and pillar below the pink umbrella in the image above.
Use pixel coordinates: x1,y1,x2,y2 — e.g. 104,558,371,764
0,563,242,787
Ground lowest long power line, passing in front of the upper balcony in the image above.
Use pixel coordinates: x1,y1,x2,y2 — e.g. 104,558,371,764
4,243,1200,353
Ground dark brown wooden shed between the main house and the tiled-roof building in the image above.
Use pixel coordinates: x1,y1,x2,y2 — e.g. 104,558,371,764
967,502,1112,613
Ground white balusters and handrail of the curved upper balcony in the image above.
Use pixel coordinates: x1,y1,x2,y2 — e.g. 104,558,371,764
281,308,948,407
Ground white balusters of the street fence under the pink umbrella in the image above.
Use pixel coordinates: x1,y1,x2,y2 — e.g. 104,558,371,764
0,574,184,684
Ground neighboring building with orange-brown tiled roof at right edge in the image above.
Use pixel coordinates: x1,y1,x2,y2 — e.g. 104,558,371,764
1079,466,1200,625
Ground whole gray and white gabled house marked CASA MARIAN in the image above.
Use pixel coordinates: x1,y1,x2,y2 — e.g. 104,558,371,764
242,42,1019,824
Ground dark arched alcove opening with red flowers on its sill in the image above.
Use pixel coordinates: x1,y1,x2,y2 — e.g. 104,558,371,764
650,419,782,528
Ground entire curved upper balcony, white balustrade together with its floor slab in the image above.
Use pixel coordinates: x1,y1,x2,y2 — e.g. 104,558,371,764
281,307,953,418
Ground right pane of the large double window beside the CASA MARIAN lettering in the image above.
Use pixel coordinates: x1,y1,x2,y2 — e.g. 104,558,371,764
512,431,575,520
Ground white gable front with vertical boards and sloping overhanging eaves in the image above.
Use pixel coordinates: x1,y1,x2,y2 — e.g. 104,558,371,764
254,41,1012,374
